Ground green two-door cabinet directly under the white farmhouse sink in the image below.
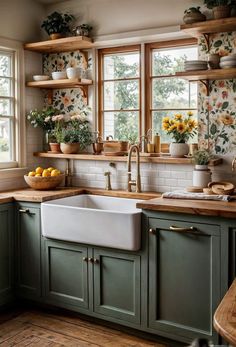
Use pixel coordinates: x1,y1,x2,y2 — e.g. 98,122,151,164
43,239,141,324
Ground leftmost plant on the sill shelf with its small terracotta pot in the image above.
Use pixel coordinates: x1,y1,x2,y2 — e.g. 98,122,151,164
26,106,59,151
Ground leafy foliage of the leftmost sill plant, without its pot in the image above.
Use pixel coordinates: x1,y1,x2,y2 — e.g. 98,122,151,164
26,106,60,133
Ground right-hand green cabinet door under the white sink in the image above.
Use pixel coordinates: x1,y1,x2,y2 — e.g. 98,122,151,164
94,249,140,324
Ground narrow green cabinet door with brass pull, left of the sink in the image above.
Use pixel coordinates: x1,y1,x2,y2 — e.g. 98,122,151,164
16,203,41,298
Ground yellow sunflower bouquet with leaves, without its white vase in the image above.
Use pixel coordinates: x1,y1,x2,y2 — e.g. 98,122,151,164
162,111,197,143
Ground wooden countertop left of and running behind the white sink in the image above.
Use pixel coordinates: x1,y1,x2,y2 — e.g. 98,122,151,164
0,187,160,204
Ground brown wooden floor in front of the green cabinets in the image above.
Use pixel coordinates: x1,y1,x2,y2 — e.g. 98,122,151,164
0,309,171,347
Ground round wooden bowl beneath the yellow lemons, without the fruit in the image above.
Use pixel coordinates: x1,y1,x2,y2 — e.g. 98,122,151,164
24,174,65,190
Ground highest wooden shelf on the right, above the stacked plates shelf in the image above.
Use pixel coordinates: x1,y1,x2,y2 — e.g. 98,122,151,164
180,17,236,38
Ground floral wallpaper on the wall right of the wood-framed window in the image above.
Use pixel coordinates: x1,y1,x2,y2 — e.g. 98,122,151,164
198,32,236,154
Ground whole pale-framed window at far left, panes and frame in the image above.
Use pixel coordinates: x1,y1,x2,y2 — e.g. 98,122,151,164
0,40,23,169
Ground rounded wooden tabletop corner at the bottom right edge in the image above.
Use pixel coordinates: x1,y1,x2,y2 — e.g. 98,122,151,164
214,279,236,346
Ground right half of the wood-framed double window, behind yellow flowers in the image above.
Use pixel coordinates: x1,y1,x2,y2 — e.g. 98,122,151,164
146,39,198,142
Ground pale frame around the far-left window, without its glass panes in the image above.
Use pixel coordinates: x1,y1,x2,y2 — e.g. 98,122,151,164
0,37,26,171
